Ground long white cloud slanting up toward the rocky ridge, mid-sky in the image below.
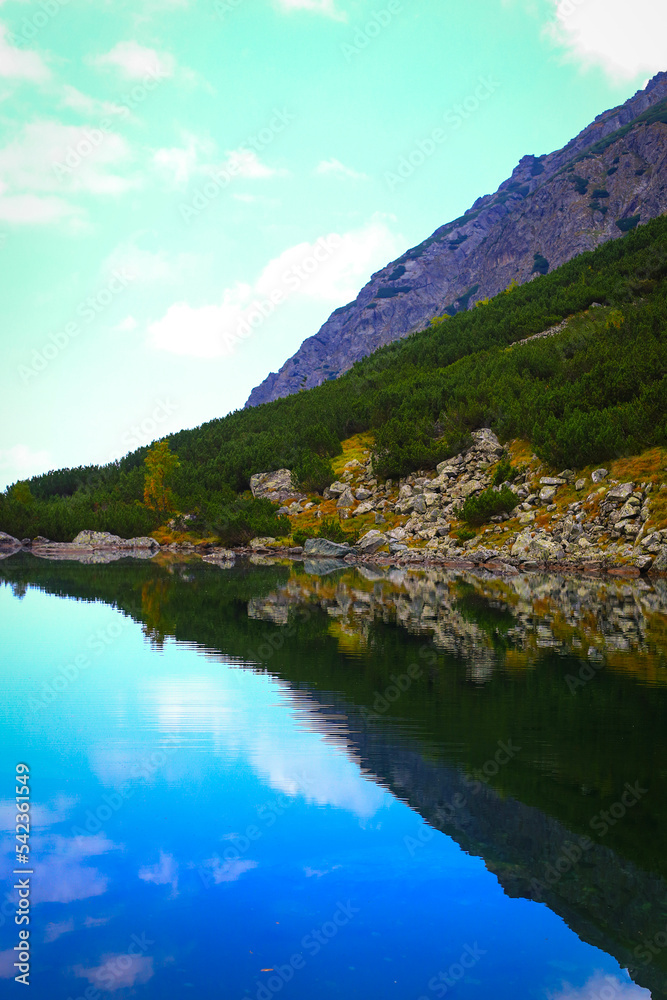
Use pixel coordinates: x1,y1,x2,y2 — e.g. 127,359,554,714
148,217,398,358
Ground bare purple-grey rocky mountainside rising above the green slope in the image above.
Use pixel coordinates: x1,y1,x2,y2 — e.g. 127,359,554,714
246,73,667,406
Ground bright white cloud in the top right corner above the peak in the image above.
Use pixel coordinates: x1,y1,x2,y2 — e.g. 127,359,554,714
545,0,667,81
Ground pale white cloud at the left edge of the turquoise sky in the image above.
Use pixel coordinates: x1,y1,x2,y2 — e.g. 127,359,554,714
0,121,137,195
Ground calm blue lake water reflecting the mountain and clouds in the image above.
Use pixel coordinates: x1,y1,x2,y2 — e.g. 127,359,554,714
0,554,667,1000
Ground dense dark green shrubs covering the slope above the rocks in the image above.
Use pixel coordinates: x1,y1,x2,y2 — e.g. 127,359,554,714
0,216,667,542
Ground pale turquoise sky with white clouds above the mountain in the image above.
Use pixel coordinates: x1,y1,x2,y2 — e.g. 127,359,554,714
0,0,667,489
